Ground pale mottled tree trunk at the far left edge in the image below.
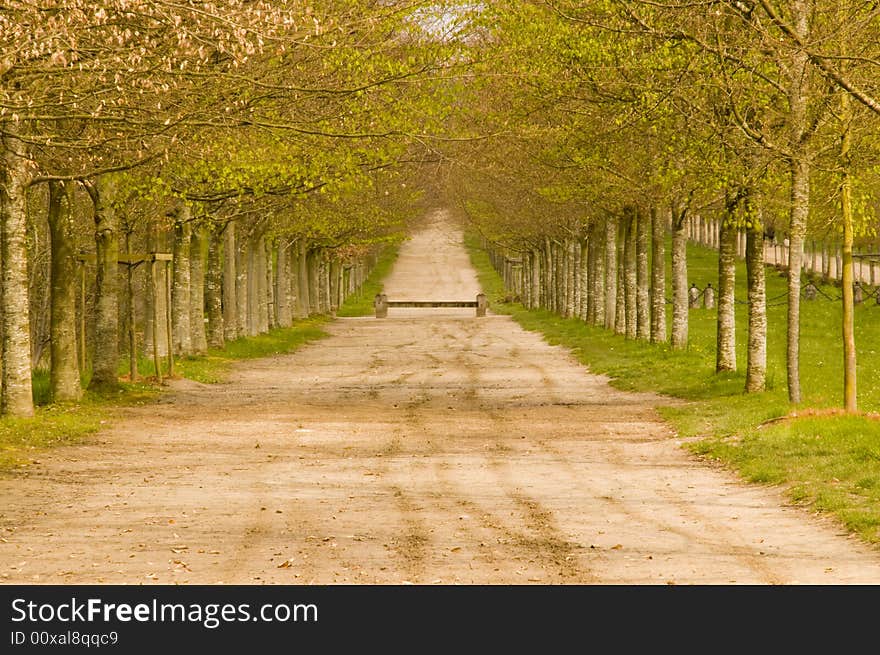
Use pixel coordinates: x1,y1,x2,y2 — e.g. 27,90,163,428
0,135,34,417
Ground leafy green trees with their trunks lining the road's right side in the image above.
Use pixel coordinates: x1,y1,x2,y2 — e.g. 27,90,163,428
444,0,880,411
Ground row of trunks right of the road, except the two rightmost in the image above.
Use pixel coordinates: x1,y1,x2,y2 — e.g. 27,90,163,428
484,201,767,392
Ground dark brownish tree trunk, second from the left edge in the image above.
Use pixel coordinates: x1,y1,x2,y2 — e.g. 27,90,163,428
48,182,82,402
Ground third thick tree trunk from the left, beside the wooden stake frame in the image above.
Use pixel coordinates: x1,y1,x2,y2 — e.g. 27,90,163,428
87,175,119,389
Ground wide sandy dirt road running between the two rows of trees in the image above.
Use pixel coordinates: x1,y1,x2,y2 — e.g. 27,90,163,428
0,214,880,585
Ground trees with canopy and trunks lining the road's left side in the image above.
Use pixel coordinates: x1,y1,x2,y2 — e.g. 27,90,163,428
0,0,459,416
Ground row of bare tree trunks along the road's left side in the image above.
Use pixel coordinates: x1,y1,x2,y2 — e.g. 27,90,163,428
0,165,384,417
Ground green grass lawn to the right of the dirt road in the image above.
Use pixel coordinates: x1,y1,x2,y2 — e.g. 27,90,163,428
466,233,880,544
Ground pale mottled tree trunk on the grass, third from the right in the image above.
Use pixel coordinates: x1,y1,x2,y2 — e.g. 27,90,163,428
745,192,767,393
